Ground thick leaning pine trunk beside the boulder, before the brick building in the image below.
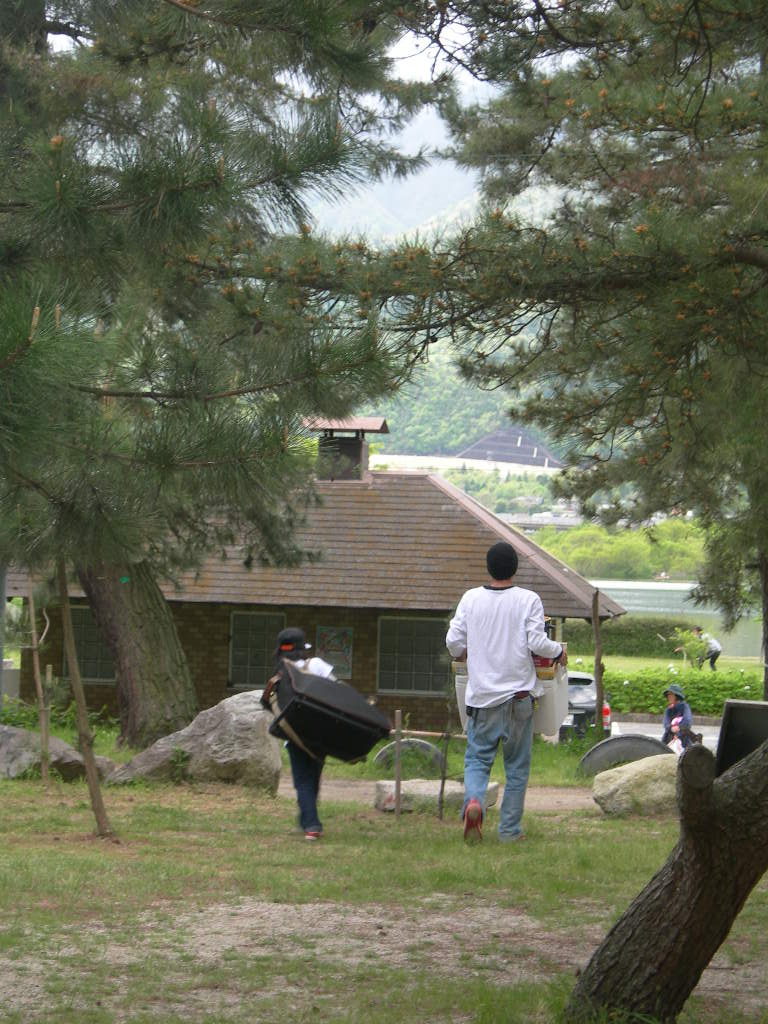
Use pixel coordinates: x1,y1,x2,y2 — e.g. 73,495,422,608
77,562,198,748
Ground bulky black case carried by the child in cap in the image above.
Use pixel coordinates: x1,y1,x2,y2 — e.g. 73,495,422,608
262,660,391,761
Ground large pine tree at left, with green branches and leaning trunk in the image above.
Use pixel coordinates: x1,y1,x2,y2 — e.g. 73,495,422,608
0,0,434,744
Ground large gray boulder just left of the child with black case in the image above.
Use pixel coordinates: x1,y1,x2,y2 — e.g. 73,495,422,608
106,691,281,795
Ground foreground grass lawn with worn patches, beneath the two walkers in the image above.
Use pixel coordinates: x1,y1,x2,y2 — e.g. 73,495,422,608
0,780,768,1024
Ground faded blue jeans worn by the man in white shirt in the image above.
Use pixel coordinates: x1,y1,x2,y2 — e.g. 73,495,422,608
462,697,534,840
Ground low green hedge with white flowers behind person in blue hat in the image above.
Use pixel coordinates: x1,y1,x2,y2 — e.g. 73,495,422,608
603,669,763,717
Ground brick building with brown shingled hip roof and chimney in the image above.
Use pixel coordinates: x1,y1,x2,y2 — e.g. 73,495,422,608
7,421,624,729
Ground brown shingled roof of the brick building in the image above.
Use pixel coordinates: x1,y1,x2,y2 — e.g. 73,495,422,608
8,473,625,618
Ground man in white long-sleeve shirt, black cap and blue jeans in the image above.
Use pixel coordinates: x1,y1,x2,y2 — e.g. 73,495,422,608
445,542,567,842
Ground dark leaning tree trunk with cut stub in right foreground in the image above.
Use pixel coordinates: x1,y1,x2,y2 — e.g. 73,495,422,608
566,741,768,1022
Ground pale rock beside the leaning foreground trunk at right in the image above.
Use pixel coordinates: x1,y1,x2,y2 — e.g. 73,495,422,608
592,754,678,817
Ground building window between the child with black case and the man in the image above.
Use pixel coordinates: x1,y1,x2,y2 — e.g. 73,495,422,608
378,616,451,693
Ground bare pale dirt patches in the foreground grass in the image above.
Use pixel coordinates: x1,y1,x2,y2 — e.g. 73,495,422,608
0,894,766,1021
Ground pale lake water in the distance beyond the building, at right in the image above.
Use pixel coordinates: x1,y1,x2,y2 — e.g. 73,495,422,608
590,580,762,658
